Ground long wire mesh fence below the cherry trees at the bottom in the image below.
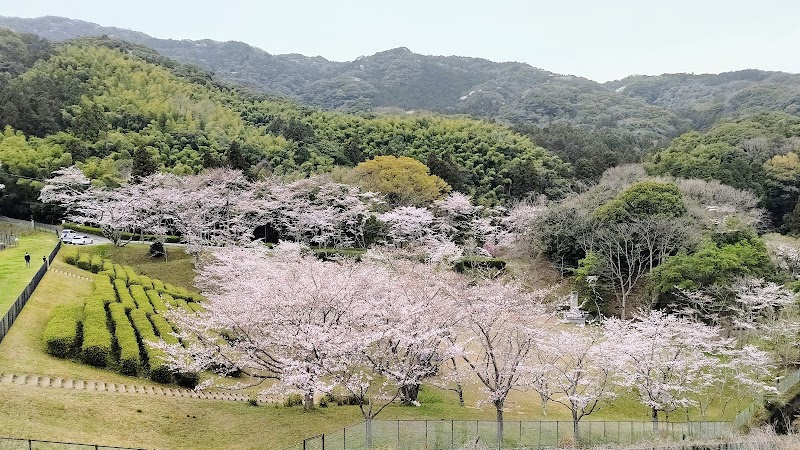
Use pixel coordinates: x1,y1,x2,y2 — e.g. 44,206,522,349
287,420,733,450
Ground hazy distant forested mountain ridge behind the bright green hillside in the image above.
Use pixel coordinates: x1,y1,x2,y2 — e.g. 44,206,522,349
0,17,689,140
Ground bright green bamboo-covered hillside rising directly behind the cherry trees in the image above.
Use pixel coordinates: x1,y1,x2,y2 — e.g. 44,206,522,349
0,31,570,217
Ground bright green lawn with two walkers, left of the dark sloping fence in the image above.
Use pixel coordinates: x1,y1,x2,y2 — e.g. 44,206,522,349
0,232,58,316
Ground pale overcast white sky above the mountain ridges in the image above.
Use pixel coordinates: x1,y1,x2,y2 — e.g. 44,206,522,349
0,0,800,81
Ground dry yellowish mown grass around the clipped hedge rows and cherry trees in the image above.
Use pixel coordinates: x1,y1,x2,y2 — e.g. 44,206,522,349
0,237,749,449
